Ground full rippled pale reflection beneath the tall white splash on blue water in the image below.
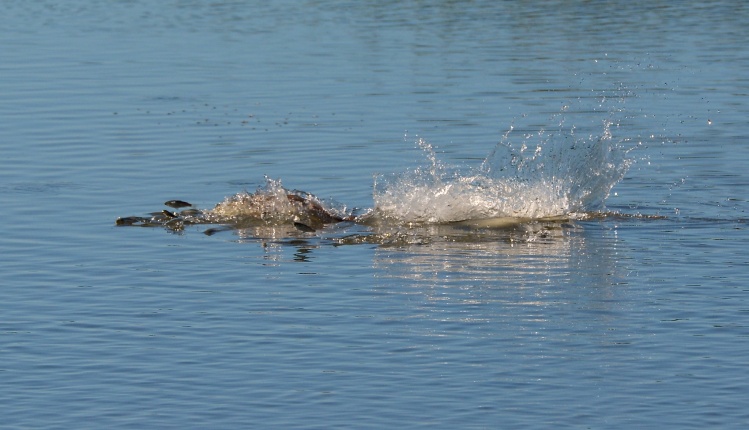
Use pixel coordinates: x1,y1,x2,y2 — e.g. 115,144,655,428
372,223,632,359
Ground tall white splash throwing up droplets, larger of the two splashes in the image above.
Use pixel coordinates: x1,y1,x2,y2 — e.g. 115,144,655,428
374,112,632,223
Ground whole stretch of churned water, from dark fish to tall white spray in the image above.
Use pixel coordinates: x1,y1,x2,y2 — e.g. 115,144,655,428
117,104,633,239
